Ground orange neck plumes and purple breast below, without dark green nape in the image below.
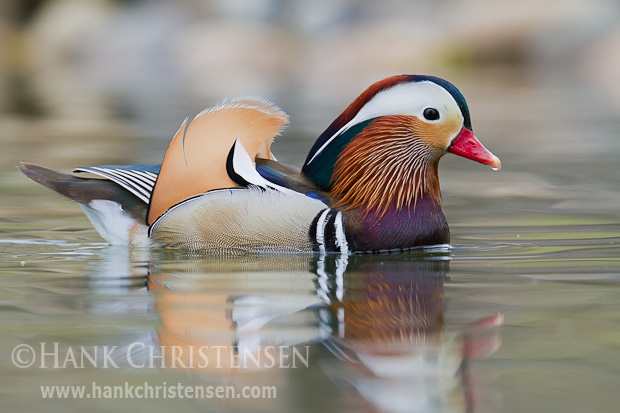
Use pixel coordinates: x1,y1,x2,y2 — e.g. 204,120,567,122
330,121,450,251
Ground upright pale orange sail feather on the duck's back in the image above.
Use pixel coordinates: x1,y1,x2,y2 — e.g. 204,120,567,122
147,99,288,225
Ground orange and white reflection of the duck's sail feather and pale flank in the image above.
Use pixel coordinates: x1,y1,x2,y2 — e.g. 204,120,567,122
148,256,328,375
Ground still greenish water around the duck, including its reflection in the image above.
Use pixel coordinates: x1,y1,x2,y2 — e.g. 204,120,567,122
0,72,620,412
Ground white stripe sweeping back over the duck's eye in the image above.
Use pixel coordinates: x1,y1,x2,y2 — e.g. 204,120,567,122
307,81,463,164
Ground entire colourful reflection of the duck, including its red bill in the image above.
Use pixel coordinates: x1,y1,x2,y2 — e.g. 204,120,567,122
143,249,499,412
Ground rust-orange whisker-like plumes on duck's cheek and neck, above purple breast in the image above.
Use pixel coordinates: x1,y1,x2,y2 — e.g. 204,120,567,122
331,115,448,216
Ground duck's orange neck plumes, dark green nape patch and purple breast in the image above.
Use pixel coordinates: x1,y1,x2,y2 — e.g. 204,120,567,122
303,115,449,251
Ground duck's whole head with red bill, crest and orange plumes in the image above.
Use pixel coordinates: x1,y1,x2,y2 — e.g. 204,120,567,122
302,75,501,215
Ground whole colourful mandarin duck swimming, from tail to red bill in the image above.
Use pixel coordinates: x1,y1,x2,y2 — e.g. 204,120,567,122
20,75,501,254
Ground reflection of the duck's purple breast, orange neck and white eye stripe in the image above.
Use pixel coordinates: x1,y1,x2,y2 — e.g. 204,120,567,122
326,256,462,412
